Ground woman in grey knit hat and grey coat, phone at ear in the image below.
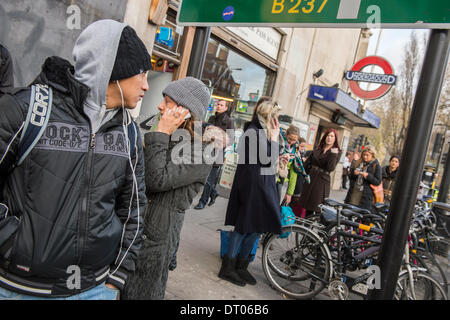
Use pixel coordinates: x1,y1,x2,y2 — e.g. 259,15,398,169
122,77,222,300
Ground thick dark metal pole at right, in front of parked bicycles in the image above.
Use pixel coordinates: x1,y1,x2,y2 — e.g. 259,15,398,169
367,30,450,300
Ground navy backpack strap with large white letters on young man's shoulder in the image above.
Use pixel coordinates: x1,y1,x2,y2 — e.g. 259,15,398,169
17,84,53,165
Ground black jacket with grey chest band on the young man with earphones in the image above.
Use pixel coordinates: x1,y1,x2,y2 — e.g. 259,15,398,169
0,57,146,296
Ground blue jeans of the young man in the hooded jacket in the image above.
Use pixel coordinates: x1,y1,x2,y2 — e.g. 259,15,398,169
0,283,119,300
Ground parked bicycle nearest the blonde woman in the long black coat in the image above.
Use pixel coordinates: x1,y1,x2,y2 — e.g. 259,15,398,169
262,199,383,299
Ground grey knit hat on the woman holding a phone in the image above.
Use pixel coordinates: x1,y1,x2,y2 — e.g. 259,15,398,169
163,77,210,120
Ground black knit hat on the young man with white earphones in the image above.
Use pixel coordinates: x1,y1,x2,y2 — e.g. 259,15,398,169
110,26,152,81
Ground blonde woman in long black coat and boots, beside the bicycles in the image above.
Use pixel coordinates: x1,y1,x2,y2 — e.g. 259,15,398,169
219,101,281,286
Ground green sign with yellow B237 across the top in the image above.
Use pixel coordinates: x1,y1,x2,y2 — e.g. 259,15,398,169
178,0,450,29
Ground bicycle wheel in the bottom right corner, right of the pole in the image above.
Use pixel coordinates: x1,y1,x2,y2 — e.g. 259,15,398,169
394,270,447,300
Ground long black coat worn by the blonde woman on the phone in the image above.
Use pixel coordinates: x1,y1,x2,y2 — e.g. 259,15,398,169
225,117,281,234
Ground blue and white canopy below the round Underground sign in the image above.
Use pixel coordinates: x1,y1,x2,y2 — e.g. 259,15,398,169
308,85,380,129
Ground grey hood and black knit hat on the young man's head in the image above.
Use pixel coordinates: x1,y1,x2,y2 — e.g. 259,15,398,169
73,20,151,132
